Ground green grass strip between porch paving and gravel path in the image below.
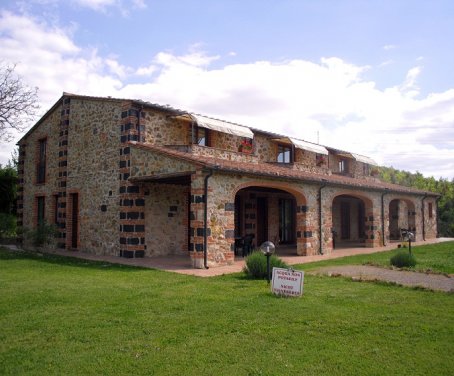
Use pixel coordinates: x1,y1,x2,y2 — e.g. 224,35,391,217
295,241,454,274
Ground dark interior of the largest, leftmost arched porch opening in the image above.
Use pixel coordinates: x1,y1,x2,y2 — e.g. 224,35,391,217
234,184,307,256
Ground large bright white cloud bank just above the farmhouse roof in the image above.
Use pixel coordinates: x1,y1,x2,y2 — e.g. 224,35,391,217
0,12,454,178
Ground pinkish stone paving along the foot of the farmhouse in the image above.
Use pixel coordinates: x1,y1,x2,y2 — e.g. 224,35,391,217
5,238,454,277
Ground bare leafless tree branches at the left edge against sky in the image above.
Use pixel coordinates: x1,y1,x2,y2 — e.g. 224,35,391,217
0,63,39,141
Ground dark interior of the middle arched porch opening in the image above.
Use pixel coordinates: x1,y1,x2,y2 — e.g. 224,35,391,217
332,194,368,249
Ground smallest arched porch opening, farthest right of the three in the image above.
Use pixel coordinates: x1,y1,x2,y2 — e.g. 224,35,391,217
389,199,416,240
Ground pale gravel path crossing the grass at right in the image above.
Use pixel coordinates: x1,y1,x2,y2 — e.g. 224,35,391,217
312,265,454,293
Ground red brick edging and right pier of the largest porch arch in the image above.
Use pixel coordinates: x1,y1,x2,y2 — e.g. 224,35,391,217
230,180,313,256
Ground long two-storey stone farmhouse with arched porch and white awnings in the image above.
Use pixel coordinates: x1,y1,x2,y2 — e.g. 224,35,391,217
18,93,438,268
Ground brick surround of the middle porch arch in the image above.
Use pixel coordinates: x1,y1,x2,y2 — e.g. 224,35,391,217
324,189,383,249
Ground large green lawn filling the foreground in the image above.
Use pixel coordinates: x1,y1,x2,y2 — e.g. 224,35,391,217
0,246,454,376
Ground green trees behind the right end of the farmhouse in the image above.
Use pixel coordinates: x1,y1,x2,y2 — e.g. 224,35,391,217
380,167,454,237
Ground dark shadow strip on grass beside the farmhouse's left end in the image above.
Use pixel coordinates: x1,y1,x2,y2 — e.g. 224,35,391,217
0,247,148,272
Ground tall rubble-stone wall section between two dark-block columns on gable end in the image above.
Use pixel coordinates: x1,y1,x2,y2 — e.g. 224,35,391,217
67,99,123,255
